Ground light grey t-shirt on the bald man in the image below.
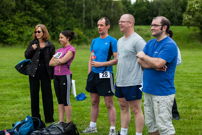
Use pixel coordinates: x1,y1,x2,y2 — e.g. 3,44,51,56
116,33,146,87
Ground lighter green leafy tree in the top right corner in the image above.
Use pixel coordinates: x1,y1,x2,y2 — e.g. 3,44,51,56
183,0,202,33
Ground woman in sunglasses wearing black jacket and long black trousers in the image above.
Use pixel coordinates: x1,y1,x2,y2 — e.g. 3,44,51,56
25,24,55,123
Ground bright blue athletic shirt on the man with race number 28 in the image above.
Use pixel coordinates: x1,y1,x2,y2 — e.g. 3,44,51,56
90,36,117,73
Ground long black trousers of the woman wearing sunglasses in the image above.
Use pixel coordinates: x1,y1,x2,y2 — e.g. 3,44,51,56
29,64,54,123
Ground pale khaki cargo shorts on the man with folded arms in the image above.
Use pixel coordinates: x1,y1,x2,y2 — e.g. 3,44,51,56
144,93,175,135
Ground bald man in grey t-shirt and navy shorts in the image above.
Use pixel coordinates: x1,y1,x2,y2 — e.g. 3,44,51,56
115,14,146,135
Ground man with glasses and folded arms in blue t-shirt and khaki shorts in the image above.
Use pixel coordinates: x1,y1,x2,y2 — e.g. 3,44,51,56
136,16,178,135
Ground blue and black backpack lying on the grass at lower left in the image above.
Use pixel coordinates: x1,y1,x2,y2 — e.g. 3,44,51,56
12,115,45,135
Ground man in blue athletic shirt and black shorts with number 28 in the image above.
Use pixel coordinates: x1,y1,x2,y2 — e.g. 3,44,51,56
81,17,118,135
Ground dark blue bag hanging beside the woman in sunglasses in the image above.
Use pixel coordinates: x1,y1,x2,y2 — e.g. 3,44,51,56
15,59,32,75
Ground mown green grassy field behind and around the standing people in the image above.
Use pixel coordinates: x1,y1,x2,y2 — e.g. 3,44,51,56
0,26,202,135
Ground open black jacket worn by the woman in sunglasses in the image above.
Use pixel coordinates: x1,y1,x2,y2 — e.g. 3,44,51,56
25,40,55,79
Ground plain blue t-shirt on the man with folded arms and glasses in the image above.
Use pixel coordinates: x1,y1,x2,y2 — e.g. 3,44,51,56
143,37,178,96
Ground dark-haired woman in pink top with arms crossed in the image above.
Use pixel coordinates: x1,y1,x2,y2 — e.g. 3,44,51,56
49,30,75,123
